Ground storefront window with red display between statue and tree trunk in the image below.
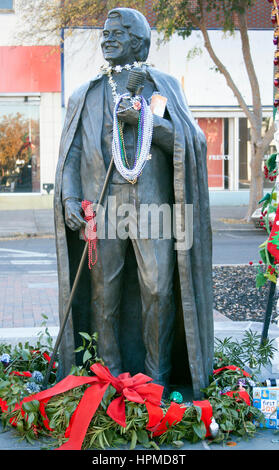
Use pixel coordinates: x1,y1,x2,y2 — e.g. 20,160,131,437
198,118,233,190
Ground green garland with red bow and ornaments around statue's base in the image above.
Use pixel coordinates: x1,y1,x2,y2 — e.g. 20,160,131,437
0,324,270,450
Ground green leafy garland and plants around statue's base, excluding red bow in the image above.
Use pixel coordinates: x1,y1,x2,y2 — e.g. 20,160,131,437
0,331,275,450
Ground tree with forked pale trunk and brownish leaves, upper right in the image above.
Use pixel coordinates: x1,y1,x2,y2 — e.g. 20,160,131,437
154,0,274,220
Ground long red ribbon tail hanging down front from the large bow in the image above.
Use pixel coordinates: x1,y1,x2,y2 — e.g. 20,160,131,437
56,382,109,450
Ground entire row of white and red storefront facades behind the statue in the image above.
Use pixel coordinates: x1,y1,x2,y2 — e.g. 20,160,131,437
0,0,274,208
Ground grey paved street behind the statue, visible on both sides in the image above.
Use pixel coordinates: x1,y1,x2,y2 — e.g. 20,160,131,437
0,231,266,328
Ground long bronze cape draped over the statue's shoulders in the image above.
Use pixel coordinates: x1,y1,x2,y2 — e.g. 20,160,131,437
54,67,214,399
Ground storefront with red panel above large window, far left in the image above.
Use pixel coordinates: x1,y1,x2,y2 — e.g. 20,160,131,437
0,0,61,209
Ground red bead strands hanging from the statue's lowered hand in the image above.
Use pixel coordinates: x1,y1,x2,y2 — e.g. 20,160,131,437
81,200,98,269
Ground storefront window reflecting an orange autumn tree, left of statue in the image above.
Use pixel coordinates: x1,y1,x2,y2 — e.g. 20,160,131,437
0,97,40,193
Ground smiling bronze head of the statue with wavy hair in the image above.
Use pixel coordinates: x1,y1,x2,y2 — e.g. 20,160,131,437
101,8,151,65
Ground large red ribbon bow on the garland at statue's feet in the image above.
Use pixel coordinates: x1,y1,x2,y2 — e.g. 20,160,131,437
23,363,164,450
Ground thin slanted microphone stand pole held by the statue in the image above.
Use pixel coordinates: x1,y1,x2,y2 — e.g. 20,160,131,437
42,156,114,390
